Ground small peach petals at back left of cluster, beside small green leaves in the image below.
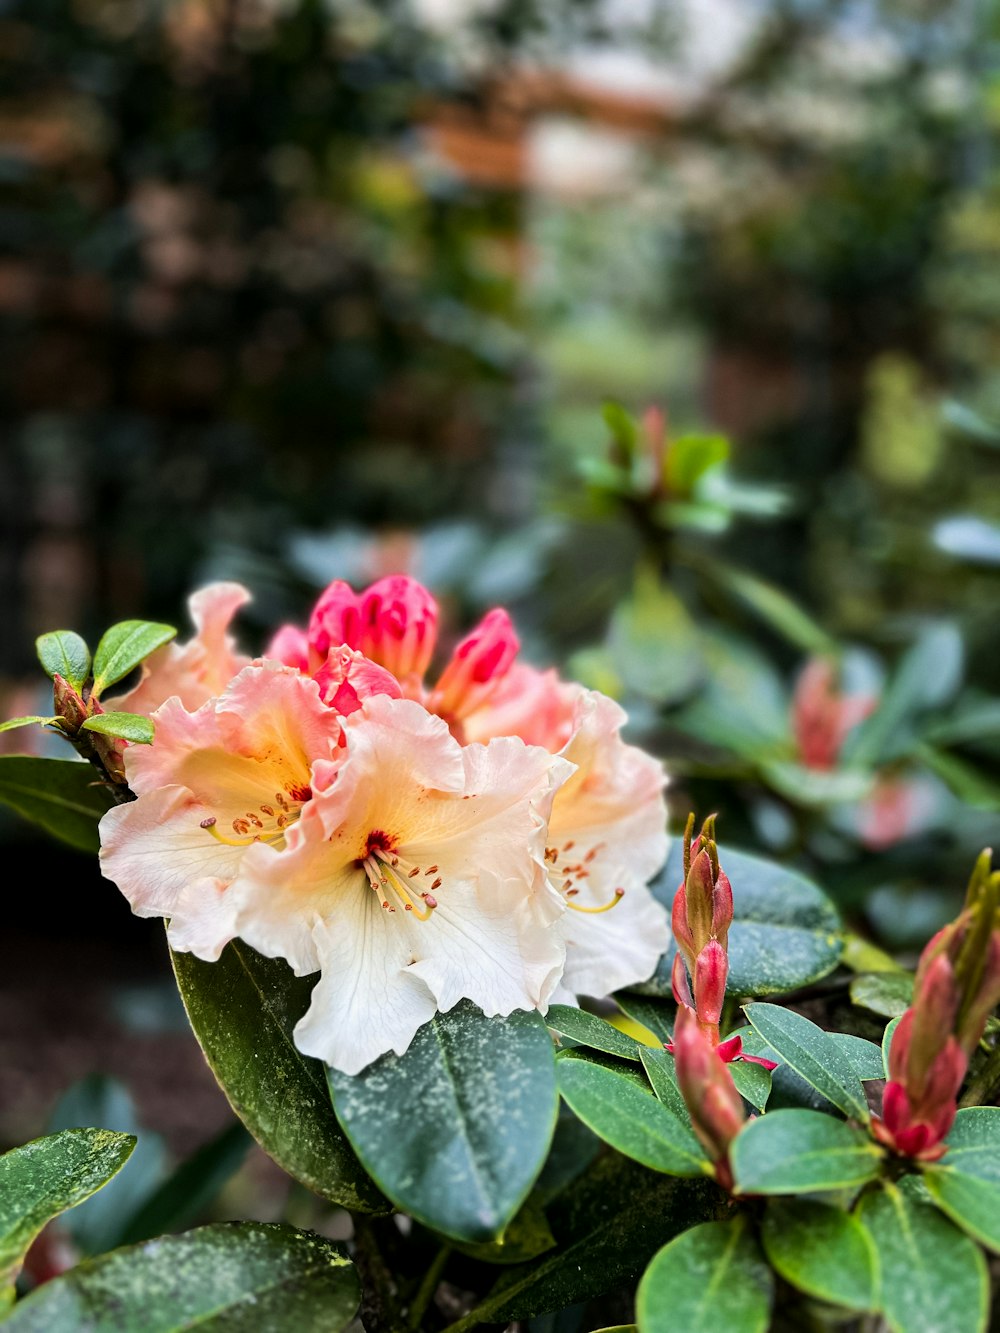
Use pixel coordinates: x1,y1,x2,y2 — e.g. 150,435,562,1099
113,583,251,716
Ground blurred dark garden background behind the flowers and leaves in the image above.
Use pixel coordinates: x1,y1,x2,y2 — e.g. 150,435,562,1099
0,0,1000,1247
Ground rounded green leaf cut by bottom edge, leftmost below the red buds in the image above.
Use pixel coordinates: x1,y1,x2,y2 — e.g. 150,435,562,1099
636,1216,775,1333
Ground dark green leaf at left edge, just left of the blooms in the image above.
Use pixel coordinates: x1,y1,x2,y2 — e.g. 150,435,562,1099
0,754,115,852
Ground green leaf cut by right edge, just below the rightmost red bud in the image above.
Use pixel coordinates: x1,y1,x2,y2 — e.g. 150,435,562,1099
924,1106,1000,1253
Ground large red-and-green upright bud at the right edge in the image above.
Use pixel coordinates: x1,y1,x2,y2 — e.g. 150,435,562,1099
875,852,1000,1161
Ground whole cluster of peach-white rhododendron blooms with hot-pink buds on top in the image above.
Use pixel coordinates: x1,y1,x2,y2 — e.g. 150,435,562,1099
101,576,669,1073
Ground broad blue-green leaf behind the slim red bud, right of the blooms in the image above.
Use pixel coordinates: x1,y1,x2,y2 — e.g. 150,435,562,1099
632,838,843,996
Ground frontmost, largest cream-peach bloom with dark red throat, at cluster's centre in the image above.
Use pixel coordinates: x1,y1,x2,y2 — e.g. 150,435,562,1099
222,694,571,1073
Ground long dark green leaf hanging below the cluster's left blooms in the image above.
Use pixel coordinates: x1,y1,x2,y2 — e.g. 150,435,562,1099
172,940,388,1212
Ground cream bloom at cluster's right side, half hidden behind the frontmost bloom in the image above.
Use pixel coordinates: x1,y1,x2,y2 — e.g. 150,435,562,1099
545,690,671,997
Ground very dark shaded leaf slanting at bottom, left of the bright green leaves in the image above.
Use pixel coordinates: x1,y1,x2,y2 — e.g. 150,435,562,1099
451,1152,723,1333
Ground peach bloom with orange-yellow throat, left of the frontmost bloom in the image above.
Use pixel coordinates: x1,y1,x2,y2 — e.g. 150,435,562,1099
100,663,341,958
